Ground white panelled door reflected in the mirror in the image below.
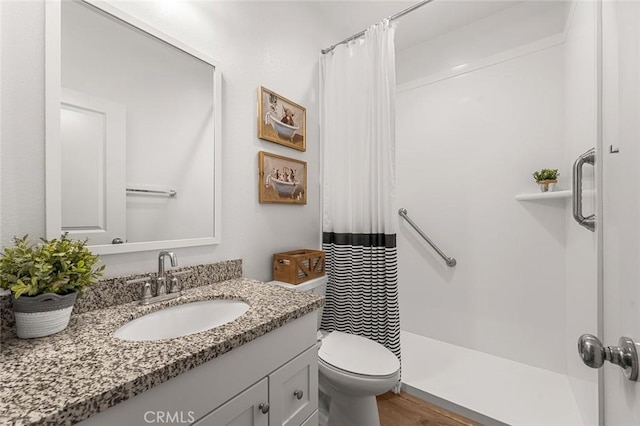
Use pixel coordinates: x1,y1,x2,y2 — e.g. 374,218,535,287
60,89,126,245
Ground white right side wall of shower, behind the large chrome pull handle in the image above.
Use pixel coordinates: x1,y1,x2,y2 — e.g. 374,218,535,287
564,0,599,425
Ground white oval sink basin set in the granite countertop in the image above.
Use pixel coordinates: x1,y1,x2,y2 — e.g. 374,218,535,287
114,299,249,341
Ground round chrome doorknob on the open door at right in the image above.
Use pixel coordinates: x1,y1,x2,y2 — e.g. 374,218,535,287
578,334,638,381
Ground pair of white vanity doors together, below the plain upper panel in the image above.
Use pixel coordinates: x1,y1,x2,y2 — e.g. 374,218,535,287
194,346,318,426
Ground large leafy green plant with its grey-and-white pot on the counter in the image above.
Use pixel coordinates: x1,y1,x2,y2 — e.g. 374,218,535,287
0,234,104,338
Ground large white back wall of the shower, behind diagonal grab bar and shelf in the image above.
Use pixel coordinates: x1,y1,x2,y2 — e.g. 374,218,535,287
397,8,571,372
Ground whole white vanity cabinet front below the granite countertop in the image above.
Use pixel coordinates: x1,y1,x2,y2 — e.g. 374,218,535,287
82,311,318,426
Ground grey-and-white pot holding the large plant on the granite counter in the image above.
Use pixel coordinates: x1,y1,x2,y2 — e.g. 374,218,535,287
13,293,77,339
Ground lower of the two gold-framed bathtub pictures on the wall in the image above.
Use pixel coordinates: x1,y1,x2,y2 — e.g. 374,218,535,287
258,151,307,204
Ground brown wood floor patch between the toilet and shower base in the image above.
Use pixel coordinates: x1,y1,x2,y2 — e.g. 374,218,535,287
378,392,480,426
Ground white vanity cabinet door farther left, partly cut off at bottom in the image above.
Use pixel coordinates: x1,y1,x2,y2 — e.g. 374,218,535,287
193,378,269,426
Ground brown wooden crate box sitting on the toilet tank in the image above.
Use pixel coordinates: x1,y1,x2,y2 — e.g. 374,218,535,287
273,250,325,284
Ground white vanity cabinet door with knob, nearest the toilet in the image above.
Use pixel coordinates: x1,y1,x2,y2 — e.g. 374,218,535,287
269,345,318,426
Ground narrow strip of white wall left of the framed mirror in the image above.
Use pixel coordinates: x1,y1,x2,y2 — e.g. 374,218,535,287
0,2,45,253
